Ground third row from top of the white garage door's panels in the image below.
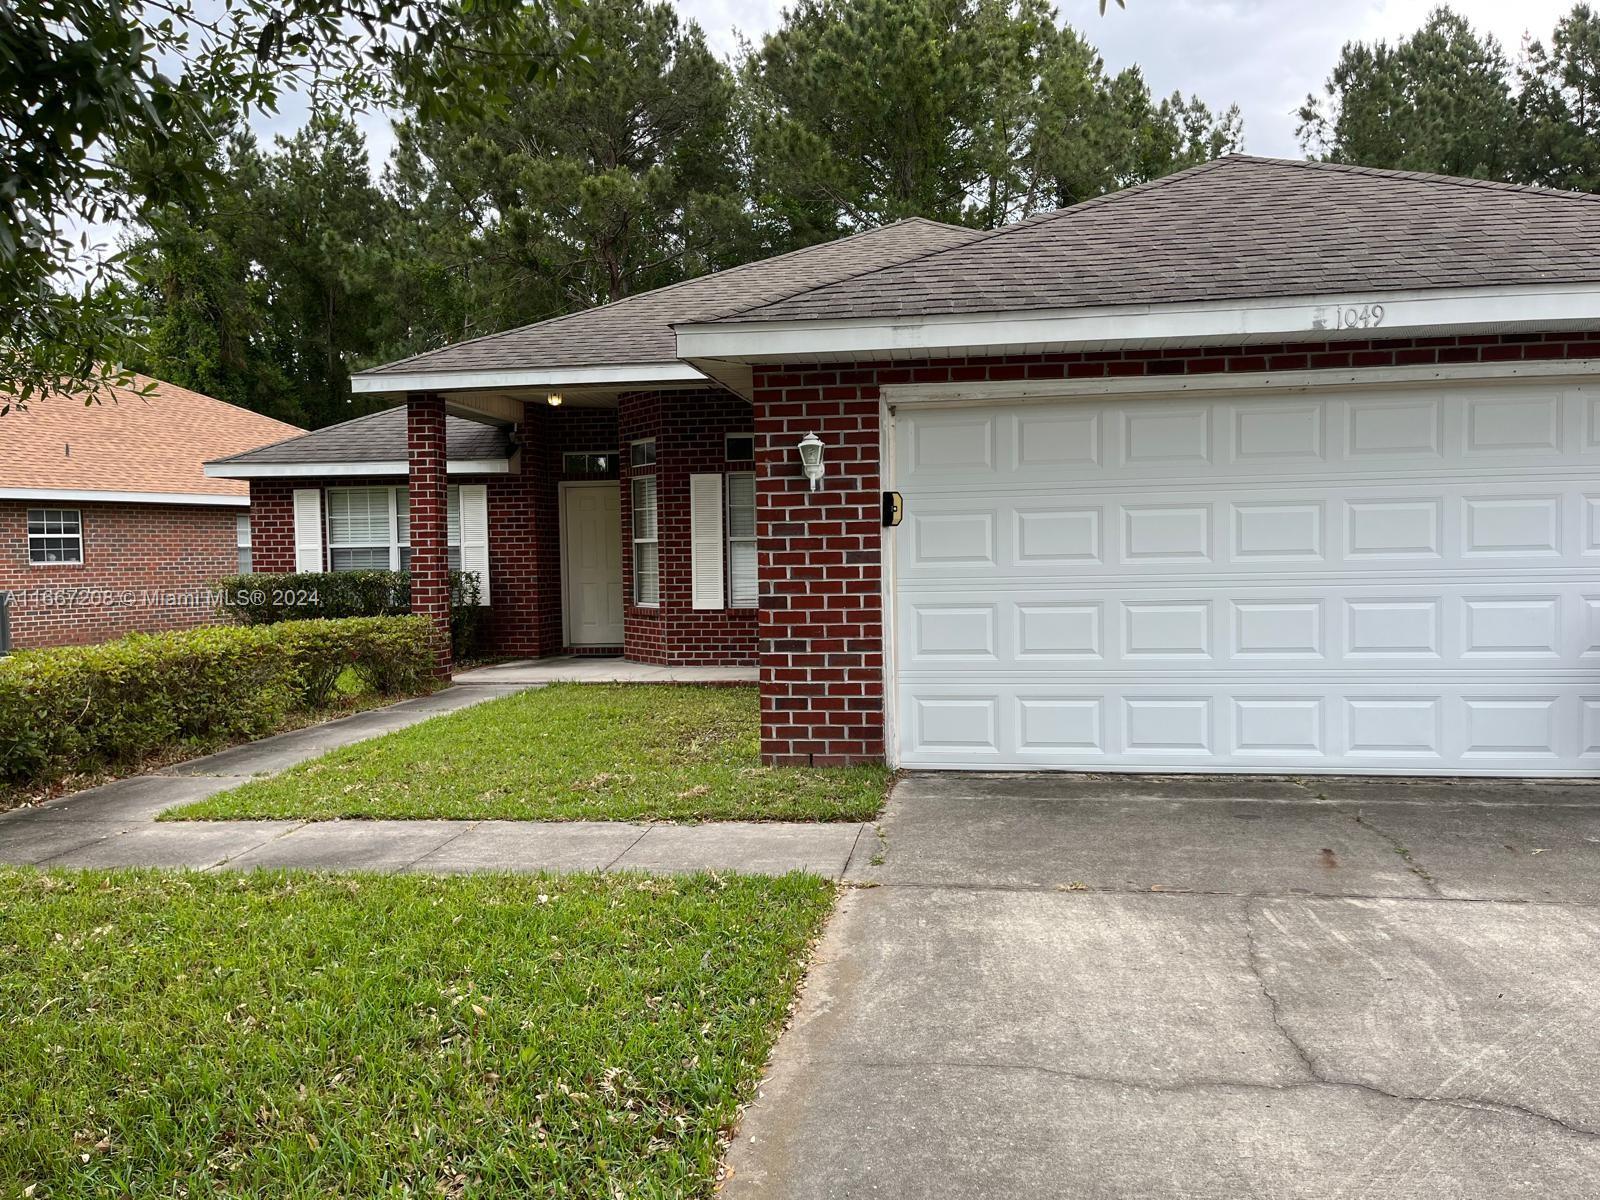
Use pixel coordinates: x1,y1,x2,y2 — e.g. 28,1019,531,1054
899,579,1600,677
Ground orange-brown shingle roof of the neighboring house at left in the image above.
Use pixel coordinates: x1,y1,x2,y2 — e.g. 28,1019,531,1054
0,374,301,496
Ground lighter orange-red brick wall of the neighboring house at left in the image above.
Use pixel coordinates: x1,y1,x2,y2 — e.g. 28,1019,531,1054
0,501,245,650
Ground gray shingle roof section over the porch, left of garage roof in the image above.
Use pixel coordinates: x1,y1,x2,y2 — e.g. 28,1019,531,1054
363,218,981,376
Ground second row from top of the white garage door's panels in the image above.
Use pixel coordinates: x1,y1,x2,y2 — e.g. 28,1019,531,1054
896,483,1600,581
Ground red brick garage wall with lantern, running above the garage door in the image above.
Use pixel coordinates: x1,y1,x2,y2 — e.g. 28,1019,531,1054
754,331,1600,763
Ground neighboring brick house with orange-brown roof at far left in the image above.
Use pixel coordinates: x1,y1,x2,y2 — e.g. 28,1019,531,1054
0,376,301,650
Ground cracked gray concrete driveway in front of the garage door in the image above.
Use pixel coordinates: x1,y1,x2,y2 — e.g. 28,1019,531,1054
726,774,1600,1200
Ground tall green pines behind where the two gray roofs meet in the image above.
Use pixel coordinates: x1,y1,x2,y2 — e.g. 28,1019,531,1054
741,0,1238,243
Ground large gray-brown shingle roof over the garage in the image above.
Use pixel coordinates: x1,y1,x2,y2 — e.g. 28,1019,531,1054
717,155,1600,323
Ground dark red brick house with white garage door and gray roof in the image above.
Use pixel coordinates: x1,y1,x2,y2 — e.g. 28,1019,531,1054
210,155,1600,774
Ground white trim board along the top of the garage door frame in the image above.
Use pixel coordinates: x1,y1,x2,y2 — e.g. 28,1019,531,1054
880,358,1600,406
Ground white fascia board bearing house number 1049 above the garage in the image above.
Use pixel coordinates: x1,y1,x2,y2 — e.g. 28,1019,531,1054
677,283,1600,362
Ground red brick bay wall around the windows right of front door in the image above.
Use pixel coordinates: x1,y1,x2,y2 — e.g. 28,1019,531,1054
619,389,758,666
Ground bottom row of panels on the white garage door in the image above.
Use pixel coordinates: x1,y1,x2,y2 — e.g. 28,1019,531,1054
898,677,1600,774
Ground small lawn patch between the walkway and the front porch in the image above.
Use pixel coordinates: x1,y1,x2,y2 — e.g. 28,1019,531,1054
165,683,890,821
